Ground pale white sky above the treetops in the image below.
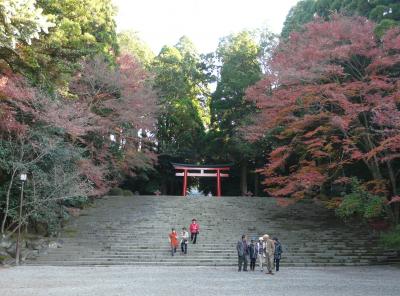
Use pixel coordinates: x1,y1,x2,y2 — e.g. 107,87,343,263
113,0,298,54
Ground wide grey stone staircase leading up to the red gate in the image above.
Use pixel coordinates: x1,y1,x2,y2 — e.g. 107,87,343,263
26,196,393,267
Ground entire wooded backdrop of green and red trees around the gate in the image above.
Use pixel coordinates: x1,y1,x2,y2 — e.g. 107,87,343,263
0,0,400,247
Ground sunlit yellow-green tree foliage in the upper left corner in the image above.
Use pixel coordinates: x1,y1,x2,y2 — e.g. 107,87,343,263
0,0,118,93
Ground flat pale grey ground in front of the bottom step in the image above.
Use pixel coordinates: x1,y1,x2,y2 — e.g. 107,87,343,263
0,266,400,296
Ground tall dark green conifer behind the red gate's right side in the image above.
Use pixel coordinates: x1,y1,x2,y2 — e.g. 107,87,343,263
211,31,263,194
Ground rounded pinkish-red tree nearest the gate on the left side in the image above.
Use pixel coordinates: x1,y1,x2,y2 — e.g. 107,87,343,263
70,54,158,187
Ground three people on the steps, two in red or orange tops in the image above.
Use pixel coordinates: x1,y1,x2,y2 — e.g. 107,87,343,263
168,219,200,256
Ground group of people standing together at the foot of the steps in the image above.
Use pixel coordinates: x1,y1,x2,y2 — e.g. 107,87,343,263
236,234,282,274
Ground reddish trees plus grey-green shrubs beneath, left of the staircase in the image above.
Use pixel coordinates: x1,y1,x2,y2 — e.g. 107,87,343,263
0,55,157,233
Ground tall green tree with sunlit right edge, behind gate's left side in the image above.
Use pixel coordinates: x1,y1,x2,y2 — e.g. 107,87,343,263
153,37,210,191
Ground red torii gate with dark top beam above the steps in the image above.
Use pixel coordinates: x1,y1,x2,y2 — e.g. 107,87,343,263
172,163,231,196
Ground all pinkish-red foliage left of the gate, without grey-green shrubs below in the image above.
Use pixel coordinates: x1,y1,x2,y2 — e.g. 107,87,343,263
0,55,158,195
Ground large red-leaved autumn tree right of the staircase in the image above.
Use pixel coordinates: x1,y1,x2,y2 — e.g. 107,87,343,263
246,15,400,213
